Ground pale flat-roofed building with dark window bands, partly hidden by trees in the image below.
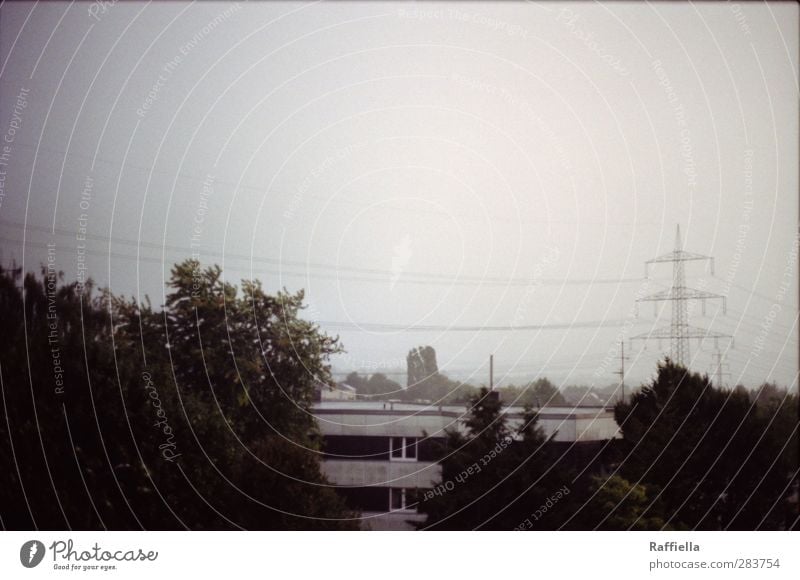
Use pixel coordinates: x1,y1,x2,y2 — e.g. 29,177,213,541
312,402,619,530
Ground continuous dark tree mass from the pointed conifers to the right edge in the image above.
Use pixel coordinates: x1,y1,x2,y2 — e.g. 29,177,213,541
418,360,798,530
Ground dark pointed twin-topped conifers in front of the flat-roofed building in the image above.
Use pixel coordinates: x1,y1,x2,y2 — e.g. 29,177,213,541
419,388,574,530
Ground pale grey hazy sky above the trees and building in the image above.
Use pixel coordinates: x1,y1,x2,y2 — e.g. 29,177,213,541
0,2,798,386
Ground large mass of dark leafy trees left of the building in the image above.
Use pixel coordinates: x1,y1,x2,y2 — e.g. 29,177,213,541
0,261,356,529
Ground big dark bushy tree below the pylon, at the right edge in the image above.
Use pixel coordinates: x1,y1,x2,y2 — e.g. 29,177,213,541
615,360,798,530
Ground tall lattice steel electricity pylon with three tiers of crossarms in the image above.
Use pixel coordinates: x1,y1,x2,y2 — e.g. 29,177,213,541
632,226,732,366
